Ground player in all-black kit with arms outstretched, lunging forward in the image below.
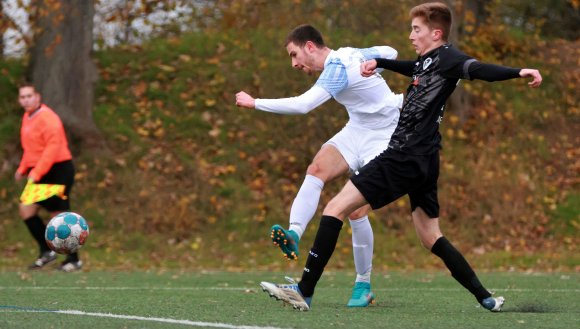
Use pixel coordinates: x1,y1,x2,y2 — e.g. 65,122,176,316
262,3,542,312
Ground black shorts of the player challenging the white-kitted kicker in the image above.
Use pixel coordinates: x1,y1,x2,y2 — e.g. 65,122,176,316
350,149,439,218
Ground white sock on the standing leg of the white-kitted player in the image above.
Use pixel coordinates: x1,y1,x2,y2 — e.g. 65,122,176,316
349,216,374,283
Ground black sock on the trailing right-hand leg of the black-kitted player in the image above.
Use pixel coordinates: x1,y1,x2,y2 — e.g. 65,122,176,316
431,237,491,302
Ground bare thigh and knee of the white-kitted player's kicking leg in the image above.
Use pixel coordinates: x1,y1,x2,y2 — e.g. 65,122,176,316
307,144,349,182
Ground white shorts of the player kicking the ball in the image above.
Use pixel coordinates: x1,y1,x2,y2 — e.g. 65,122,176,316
324,120,398,172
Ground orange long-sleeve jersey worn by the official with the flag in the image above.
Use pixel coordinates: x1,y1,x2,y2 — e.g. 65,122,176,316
17,104,72,182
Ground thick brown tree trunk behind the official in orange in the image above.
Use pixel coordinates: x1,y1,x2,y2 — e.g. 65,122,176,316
28,0,105,150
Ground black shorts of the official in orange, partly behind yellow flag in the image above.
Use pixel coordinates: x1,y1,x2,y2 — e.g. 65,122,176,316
31,160,75,212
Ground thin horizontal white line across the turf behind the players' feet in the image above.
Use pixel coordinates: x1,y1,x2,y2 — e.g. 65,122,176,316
0,286,580,293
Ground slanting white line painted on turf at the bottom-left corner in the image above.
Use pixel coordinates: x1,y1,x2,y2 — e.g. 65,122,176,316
0,307,281,329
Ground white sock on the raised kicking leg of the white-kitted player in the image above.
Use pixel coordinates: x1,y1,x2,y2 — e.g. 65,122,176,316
290,175,324,237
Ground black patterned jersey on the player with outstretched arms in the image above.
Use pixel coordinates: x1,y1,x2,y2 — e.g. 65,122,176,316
389,45,475,155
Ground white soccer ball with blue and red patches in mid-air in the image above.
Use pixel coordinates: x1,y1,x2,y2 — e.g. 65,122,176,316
44,212,89,254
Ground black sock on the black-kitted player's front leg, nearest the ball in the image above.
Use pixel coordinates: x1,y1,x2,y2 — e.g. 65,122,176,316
298,216,342,297
